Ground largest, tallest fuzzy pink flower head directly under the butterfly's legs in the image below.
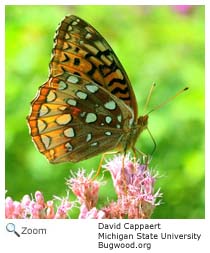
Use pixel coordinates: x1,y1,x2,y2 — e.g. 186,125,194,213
103,155,161,219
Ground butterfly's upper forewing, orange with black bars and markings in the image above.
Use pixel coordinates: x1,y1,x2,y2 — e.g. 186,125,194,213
50,16,137,120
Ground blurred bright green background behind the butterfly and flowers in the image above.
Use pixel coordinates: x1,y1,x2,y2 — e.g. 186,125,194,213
5,5,205,218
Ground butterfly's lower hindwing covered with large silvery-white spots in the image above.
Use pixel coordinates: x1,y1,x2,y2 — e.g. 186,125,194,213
28,72,134,163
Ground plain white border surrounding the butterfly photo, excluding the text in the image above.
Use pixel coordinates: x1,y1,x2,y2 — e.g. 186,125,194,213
0,0,210,253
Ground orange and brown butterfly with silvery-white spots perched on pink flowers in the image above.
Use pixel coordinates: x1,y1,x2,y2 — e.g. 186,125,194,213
28,16,148,163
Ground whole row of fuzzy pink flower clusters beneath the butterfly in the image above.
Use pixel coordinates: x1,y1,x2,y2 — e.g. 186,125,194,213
5,155,162,219
